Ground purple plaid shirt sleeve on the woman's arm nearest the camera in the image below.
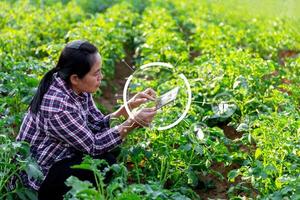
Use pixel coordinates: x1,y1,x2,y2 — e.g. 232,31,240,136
49,111,122,156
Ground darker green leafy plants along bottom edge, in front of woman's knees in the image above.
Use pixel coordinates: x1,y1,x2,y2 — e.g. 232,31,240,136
65,156,197,200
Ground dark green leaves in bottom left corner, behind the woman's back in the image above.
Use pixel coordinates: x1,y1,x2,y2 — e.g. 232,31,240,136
0,134,43,200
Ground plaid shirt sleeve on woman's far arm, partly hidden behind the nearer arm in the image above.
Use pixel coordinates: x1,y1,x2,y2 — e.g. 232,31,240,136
88,94,110,131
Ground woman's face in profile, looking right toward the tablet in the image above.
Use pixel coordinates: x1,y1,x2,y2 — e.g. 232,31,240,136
73,53,103,94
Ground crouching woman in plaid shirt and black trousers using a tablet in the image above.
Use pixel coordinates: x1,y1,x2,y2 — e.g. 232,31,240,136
17,40,156,199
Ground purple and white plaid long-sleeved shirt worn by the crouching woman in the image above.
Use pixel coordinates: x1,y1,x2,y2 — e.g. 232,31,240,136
17,73,122,190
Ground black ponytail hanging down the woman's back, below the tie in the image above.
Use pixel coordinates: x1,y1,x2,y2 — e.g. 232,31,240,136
30,67,58,114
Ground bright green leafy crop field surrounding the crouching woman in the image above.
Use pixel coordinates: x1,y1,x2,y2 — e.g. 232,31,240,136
0,0,300,200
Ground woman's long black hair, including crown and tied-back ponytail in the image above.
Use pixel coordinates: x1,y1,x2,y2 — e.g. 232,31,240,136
30,40,98,114
